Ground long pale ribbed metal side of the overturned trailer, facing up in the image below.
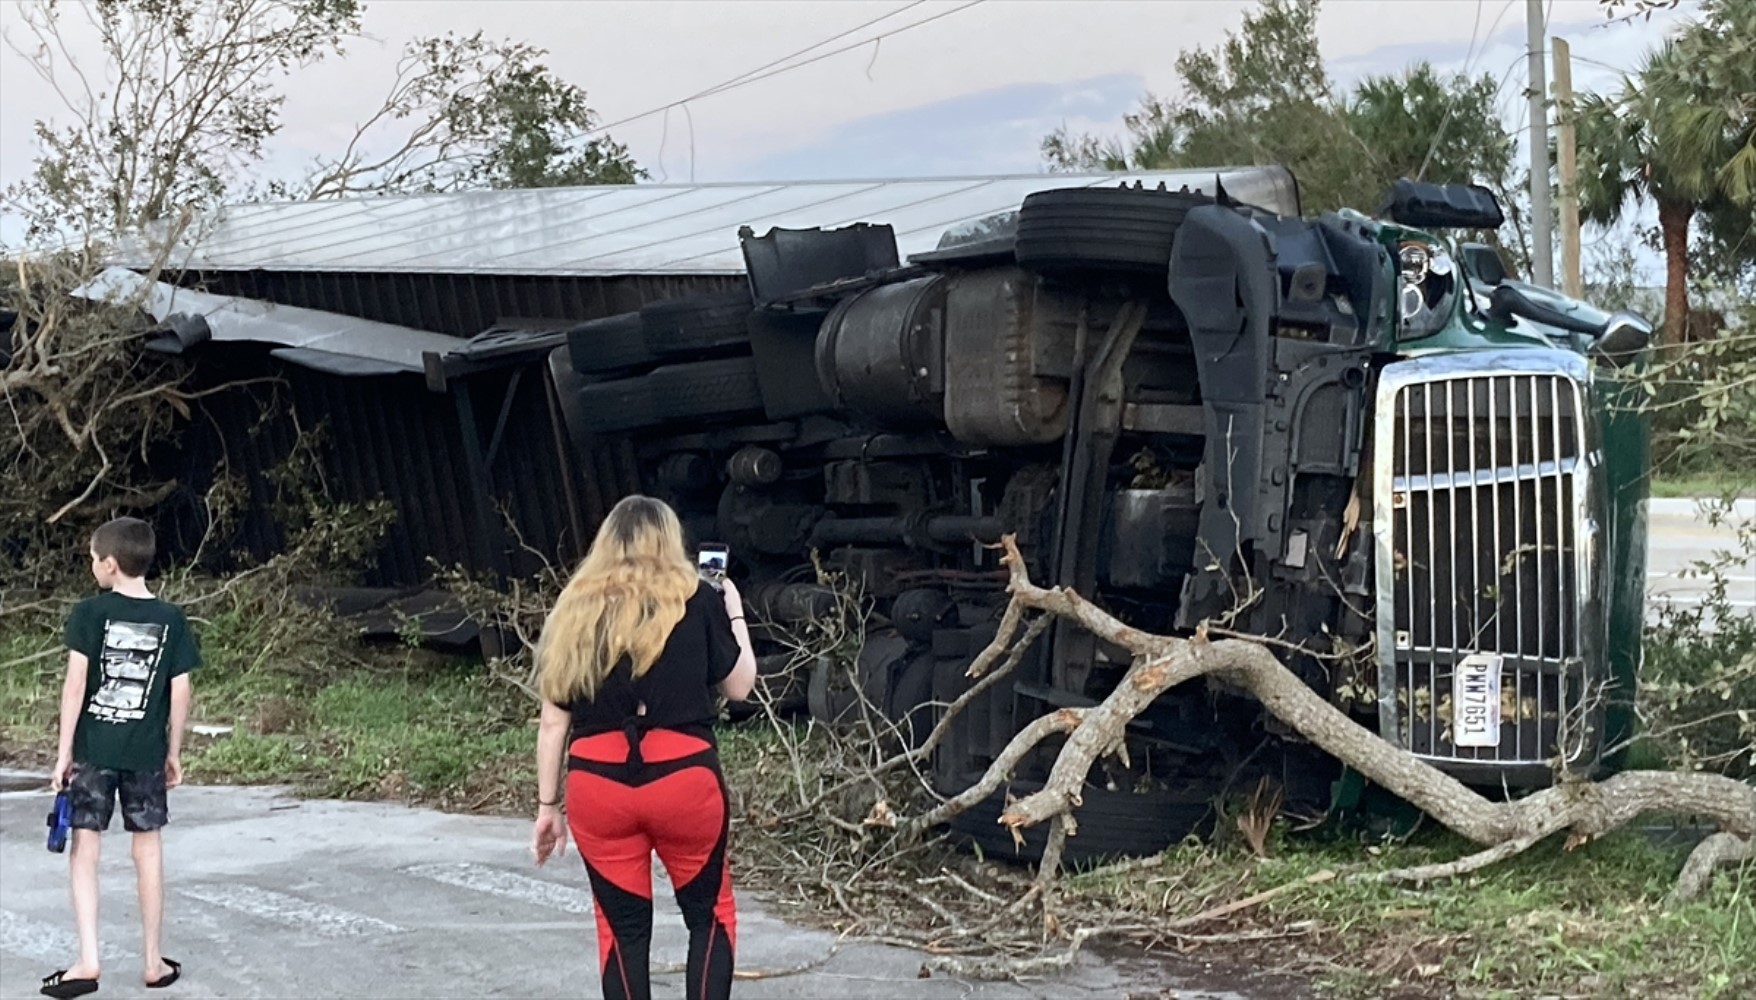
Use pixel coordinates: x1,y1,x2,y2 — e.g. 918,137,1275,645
112,167,1298,278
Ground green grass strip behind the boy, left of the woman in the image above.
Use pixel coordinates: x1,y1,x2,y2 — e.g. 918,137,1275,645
0,619,536,812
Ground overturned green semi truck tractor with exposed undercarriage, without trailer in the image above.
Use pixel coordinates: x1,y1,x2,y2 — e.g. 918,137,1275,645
551,169,1651,856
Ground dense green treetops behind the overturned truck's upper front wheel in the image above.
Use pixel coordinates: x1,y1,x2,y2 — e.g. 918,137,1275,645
1043,0,1514,237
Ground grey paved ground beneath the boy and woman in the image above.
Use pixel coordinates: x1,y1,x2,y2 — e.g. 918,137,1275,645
0,787,1264,1000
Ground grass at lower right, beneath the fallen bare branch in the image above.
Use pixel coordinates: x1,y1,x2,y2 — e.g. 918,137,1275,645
1073,831,1756,1000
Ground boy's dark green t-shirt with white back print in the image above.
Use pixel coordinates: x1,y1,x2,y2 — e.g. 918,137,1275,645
67,592,202,772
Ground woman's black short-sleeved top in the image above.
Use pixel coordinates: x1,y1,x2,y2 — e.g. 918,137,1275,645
562,582,738,742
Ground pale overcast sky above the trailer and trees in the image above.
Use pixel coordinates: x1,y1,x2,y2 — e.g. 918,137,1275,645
0,0,1688,268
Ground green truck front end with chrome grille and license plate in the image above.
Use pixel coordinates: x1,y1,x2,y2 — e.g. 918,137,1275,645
1354,183,1652,787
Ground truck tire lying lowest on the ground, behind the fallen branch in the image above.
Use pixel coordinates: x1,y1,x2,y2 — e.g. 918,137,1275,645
950,779,1213,866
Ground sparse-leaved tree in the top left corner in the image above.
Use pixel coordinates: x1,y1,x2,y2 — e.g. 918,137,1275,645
7,0,360,243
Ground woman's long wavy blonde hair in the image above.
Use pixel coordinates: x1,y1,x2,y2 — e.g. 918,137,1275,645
537,496,699,705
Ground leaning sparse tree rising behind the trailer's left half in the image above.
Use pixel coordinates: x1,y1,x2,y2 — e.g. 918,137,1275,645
288,32,646,199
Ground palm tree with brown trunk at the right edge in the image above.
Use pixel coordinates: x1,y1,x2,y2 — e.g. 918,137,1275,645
1575,0,1756,344
